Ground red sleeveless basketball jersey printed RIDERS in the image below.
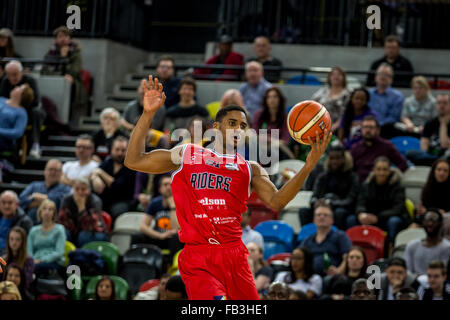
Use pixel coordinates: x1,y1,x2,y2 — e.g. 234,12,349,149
172,144,251,244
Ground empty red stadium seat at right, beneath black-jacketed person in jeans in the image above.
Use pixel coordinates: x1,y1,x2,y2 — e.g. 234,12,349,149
346,226,386,264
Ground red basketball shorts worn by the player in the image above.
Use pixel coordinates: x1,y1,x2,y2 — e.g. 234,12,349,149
178,241,259,300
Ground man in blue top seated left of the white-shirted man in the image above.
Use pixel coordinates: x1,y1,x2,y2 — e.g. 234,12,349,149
19,159,70,224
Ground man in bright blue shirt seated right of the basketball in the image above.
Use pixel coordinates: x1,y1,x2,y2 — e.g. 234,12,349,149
368,63,404,139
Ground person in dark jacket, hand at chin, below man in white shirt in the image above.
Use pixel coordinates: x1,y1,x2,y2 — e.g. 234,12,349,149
59,178,108,247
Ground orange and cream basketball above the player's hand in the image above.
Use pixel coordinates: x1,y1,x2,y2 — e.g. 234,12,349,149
287,100,331,145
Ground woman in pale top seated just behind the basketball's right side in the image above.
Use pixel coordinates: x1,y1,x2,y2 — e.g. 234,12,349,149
311,67,350,131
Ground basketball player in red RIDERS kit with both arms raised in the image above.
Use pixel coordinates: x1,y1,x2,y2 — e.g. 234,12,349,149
125,76,331,300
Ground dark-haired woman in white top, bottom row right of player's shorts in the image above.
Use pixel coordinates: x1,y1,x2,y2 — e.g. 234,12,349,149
269,247,322,300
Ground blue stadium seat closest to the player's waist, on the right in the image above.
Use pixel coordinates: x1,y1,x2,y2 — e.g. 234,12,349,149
255,220,294,259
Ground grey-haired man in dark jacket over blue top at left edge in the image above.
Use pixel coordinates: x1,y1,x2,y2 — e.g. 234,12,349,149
0,190,33,252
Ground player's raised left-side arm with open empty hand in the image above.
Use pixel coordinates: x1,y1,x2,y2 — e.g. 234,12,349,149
125,76,181,174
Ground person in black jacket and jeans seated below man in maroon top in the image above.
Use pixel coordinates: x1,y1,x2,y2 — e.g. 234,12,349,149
347,156,410,244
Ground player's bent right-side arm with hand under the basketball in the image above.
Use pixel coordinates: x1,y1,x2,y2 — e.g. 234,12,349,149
251,130,331,211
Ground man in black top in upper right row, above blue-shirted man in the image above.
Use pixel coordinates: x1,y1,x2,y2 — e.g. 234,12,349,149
367,35,414,88
